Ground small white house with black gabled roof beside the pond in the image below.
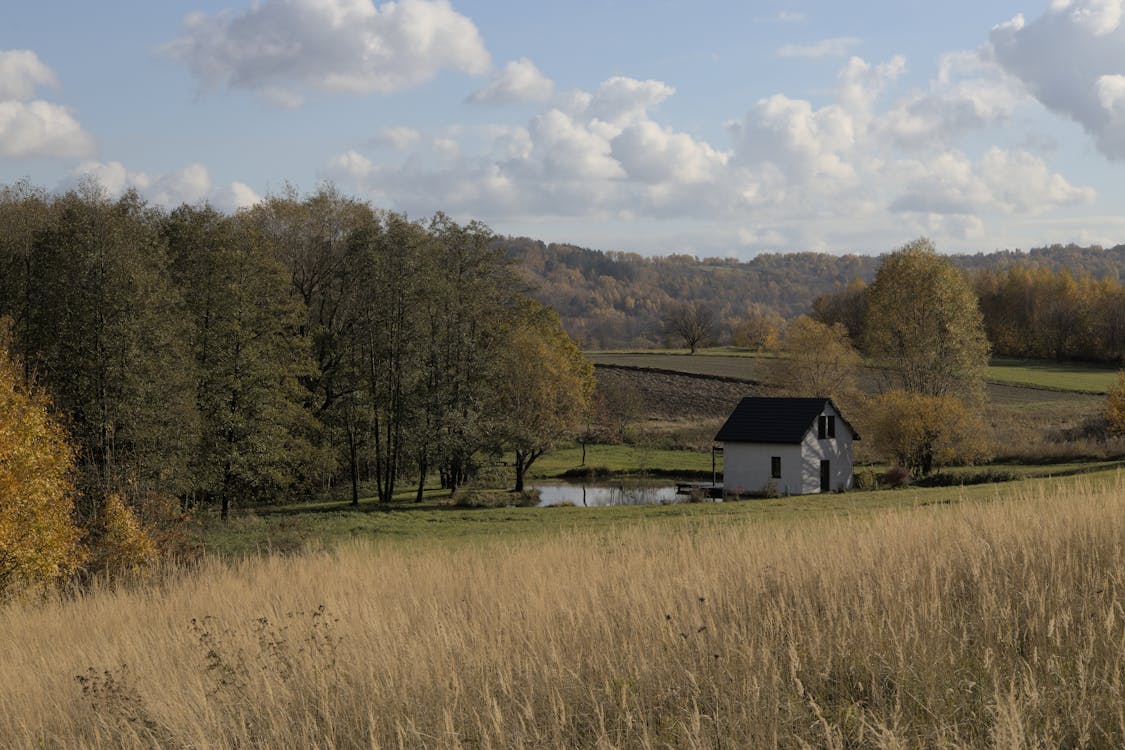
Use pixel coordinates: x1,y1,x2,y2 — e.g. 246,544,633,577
714,396,860,495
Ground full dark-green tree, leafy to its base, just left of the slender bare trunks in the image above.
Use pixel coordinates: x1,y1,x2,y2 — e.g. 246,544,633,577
165,206,322,518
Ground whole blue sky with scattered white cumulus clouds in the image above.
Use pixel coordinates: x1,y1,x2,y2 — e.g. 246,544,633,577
0,0,1125,259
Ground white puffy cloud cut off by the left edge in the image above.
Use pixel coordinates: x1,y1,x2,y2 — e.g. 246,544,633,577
0,49,95,159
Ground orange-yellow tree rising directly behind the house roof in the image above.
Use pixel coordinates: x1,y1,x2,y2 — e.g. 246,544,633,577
768,315,862,406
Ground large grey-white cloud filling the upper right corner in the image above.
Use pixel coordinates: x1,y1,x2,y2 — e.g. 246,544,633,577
989,0,1125,159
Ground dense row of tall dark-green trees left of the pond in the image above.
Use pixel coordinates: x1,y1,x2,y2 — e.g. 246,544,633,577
0,182,593,539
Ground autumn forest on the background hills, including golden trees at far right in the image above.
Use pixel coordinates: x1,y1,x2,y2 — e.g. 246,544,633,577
497,237,1125,363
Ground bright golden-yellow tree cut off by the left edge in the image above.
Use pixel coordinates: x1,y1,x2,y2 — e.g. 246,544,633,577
0,336,82,599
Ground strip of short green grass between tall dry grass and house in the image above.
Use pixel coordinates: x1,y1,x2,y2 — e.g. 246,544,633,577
198,459,1125,557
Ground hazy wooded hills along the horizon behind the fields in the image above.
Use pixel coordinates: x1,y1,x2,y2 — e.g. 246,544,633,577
497,237,1125,349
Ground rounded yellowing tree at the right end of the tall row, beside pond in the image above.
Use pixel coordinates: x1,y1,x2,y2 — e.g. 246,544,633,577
491,299,595,493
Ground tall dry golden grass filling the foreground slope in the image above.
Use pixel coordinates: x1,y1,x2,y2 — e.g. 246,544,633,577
0,475,1125,748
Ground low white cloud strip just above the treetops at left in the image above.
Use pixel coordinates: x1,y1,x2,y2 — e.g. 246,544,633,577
64,161,261,210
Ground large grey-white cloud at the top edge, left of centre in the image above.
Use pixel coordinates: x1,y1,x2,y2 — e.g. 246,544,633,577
163,0,491,107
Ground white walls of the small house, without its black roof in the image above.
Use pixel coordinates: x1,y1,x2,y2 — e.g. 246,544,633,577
722,405,852,495
